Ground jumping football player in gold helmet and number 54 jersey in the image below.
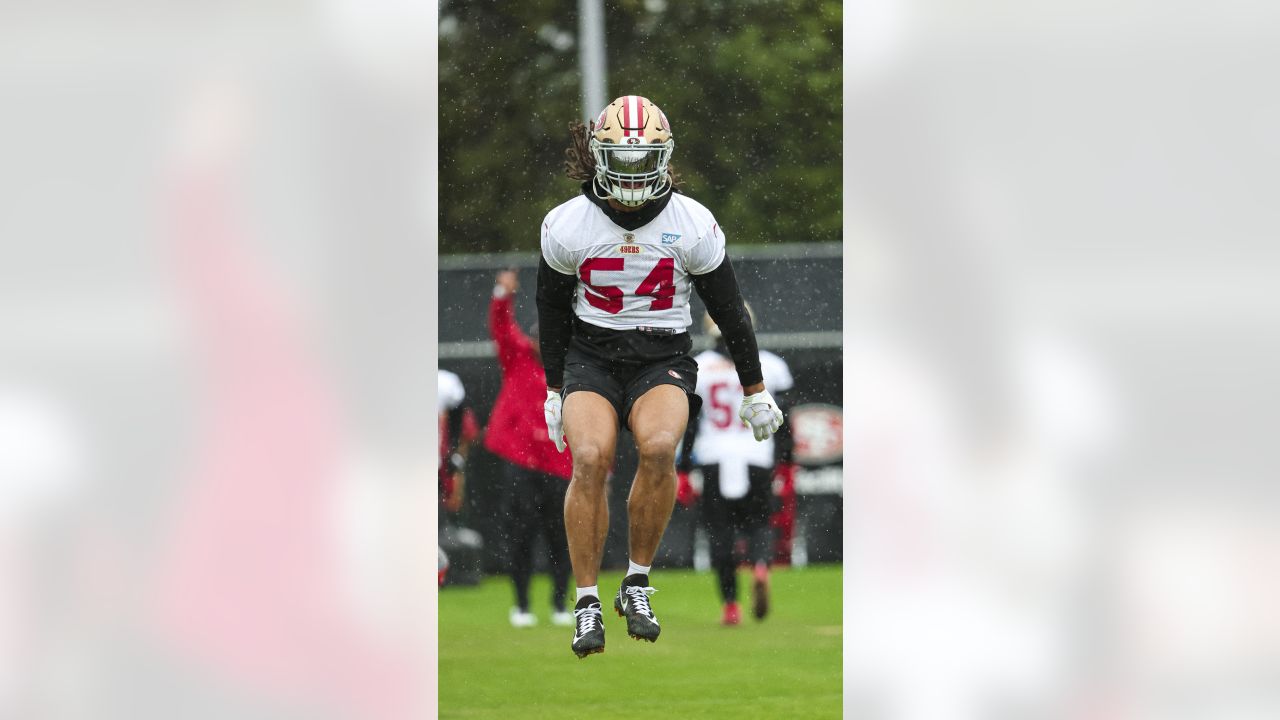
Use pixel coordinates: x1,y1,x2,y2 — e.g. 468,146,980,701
538,95,782,659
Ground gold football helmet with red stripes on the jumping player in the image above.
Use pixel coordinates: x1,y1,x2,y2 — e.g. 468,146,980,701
588,95,676,208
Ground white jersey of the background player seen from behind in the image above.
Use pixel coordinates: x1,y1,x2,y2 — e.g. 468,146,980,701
694,350,795,498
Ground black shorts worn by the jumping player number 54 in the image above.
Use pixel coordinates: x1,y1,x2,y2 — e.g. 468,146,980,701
561,319,701,429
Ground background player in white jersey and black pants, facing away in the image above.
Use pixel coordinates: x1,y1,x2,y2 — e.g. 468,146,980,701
677,304,795,625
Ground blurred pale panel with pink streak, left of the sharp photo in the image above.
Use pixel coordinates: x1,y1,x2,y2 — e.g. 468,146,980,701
0,1,435,720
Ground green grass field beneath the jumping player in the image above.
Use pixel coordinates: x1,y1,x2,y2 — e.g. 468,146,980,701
439,565,841,720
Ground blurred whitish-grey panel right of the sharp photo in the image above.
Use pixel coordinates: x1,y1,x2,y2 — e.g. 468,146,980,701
845,0,1280,720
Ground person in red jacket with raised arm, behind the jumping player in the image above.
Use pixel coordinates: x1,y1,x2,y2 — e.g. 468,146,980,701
484,270,573,628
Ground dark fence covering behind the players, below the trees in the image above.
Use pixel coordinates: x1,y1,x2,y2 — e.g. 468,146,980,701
439,243,844,573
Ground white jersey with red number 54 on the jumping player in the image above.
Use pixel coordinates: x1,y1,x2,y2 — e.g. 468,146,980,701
543,193,724,331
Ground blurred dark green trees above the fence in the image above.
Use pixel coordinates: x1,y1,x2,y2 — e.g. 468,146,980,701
439,0,841,252
